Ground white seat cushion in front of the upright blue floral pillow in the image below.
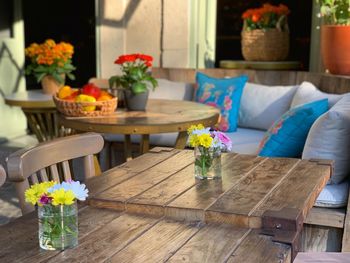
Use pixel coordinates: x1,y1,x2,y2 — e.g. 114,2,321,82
226,128,265,154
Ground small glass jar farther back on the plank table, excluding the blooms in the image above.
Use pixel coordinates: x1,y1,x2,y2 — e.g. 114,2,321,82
194,146,221,179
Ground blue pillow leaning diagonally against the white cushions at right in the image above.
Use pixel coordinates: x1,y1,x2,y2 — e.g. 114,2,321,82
258,99,328,157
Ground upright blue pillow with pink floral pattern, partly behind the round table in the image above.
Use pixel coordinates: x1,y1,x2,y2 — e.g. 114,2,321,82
194,72,248,132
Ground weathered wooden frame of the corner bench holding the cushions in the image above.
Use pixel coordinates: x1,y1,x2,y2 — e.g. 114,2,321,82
152,68,350,252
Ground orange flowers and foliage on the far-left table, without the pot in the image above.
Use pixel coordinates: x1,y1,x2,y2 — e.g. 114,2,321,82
25,39,75,84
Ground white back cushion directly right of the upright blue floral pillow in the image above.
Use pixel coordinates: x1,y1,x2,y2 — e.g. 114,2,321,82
238,82,297,130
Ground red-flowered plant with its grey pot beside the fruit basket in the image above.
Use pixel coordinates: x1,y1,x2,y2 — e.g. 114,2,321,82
109,54,158,111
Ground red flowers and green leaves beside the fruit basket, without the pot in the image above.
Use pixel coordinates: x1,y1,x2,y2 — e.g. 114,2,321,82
109,54,158,94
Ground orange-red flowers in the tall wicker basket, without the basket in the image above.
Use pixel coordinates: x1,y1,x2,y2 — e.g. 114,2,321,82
242,4,289,30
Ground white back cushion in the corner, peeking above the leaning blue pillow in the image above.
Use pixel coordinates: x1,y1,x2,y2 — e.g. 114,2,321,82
290,81,343,108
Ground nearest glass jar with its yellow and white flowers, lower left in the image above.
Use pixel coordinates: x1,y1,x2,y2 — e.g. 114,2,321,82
25,181,88,250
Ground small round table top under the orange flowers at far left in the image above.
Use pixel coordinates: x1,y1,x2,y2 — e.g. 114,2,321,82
5,90,56,108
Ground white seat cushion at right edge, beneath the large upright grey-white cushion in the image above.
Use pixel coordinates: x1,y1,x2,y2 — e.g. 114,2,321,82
315,181,349,208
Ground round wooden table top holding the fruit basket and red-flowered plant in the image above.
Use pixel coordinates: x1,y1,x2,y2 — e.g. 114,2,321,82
59,99,219,134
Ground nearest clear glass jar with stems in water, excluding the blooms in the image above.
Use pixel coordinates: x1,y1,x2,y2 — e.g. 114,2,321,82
38,202,78,250
